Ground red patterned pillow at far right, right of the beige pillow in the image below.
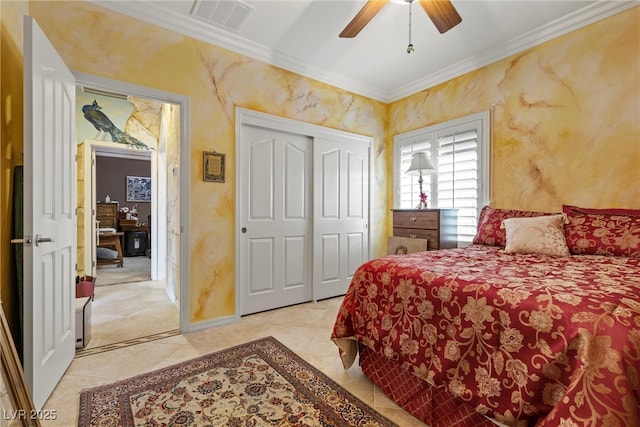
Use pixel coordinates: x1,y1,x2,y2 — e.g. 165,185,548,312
562,205,640,258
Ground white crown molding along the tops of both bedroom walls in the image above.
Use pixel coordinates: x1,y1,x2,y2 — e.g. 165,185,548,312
88,0,639,103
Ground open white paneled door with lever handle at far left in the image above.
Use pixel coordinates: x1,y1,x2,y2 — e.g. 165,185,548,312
23,16,76,409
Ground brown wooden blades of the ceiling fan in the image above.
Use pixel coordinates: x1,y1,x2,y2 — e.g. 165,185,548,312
340,0,462,38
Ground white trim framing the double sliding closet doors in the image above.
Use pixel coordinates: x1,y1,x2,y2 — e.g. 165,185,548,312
235,107,375,321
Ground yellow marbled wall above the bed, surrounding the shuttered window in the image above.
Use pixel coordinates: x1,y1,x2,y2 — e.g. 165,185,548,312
389,7,640,212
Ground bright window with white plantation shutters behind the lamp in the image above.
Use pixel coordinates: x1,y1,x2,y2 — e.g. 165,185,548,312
394,111,489,246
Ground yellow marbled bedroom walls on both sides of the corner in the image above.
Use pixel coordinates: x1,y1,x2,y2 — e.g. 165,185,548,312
2,2,640,330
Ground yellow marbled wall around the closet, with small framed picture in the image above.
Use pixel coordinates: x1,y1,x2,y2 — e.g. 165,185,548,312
29,1,388,322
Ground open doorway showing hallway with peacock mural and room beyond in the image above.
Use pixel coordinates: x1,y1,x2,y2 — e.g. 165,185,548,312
76,86,181,354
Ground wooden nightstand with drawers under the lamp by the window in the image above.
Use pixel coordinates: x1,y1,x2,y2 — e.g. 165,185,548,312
392,209,458,251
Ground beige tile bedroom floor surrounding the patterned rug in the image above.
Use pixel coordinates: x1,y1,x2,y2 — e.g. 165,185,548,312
43,287,425,427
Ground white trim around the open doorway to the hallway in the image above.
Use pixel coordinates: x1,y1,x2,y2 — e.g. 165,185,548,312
72,71,195,333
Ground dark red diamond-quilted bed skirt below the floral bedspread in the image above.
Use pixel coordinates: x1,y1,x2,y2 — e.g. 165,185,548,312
359,345,495,427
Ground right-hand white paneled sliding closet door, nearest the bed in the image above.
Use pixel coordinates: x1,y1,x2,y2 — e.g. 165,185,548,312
313,138,369,300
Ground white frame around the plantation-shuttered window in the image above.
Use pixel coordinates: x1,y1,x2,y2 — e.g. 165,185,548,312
393,110,491,244
